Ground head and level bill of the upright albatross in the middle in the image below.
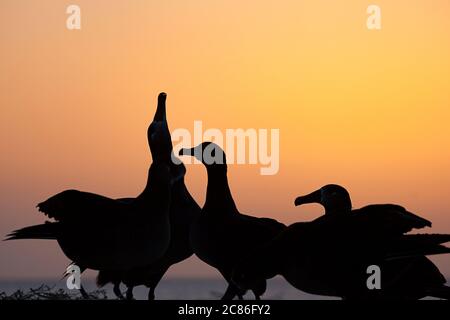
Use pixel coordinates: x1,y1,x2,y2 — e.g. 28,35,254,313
179,141,227,168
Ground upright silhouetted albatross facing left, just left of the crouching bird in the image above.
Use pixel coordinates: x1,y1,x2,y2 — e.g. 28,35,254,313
180,142,285,299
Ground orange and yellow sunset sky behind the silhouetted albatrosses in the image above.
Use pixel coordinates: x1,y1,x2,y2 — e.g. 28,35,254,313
0,0,450,279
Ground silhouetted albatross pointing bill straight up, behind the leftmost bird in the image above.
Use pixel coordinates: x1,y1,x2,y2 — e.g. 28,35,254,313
97,92,200,300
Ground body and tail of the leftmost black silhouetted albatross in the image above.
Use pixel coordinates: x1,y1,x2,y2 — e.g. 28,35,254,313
8,163,170,270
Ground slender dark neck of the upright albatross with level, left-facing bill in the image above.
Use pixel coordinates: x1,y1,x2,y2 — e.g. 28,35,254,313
204,165,238,214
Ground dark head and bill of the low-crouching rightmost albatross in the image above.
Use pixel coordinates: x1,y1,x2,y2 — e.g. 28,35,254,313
295,184,352,214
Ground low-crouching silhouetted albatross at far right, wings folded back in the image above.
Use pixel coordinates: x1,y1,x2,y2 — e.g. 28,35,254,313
233,187,450,299
